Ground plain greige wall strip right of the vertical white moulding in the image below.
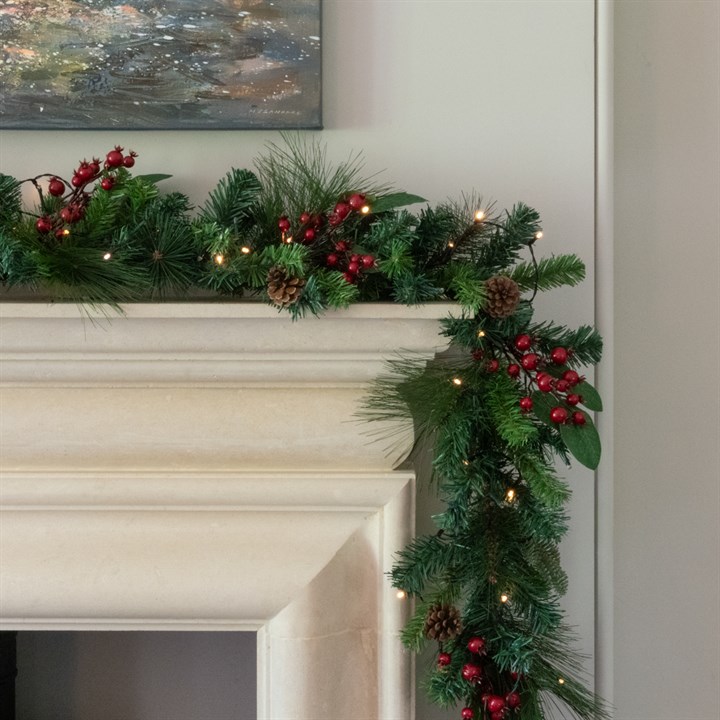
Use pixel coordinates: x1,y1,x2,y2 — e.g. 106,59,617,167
614,0,720,720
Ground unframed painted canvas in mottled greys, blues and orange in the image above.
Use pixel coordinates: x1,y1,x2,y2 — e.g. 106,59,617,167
0,0,321,129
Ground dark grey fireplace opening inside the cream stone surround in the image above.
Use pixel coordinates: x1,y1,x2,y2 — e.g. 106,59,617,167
15,631,257,720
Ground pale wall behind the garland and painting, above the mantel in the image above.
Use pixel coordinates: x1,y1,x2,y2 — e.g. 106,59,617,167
0,0,594,718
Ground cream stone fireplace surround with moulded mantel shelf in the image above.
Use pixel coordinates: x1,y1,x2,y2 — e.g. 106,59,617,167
0,302,452,720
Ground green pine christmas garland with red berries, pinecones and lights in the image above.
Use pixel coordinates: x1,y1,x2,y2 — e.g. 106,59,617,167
0,137,605,720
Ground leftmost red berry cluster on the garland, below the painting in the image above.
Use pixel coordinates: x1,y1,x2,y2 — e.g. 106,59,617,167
35,145,137,238
